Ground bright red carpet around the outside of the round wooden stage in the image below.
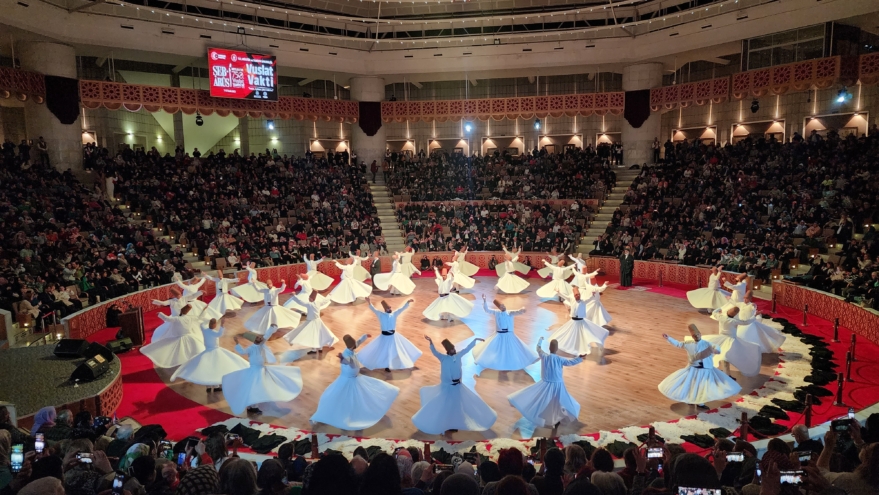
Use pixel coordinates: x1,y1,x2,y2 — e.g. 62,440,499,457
84,278,879,444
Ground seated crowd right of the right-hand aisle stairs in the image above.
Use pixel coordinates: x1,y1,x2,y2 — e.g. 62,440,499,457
593,129,879,307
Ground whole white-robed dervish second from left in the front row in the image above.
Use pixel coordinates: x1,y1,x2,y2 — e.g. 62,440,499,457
311,335,400,430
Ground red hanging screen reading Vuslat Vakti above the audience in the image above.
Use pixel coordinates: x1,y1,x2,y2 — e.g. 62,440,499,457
208,48,278,101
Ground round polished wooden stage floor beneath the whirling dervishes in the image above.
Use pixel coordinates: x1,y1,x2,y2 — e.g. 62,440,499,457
157,277,778,440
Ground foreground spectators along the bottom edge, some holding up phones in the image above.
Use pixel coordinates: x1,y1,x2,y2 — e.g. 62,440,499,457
0,407,879,495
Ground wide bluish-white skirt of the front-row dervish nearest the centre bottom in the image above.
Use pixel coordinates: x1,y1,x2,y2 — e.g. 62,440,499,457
412,383,497,435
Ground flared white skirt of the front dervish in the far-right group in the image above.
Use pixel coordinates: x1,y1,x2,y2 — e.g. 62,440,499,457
659,366,742,404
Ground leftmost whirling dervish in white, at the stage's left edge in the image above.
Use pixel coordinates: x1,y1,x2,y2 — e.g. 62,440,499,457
140,305,205,368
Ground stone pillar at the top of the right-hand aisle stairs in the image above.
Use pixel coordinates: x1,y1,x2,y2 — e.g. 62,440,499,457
622,62,663,165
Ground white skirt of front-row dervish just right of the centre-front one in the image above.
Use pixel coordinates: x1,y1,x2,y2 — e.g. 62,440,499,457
507,380,580,426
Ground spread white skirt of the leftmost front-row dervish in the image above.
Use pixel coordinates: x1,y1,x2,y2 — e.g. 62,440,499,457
223,365,302,414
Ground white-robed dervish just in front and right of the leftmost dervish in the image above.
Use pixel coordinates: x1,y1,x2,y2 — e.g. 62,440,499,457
171,319,248,391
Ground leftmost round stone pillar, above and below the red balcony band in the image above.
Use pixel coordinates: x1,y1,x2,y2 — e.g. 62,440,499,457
18,41,82,171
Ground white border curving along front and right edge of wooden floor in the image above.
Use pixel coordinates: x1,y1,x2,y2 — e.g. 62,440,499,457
201,319,812,459
